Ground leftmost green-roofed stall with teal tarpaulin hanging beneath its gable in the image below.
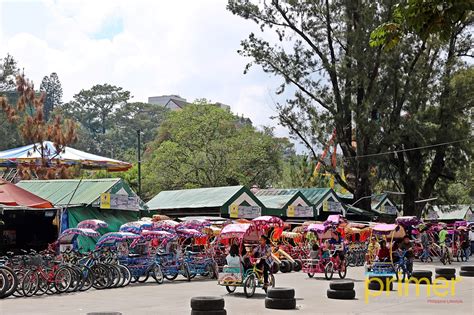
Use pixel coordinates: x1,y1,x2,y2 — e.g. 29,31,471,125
17,178,146,250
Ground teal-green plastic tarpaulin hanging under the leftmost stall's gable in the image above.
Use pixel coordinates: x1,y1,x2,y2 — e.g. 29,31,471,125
67,207,138,251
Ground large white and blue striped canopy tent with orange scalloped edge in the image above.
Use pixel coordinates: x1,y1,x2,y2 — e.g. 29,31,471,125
0,141,132,172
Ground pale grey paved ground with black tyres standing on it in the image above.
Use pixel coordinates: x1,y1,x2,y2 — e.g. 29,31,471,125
0,262,474,315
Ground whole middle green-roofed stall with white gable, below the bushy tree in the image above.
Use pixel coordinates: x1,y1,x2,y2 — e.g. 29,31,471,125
147,186,263,219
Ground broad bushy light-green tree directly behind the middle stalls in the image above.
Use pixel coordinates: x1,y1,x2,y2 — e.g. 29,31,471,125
144,105,286,196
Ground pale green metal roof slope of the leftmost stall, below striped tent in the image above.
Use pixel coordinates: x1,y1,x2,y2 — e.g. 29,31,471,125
17,178,121,206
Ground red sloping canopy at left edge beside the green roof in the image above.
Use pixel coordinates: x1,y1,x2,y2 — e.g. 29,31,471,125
0,179,54,209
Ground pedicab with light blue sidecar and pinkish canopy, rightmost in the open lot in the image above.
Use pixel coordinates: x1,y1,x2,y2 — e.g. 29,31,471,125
365,223,410,281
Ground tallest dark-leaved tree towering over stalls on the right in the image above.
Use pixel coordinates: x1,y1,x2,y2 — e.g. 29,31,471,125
228,0,472,215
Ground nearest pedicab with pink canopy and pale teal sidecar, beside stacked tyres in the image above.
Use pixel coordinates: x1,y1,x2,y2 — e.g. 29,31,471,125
217,220,277,298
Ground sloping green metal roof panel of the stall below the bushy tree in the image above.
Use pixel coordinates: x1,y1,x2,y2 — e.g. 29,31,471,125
147,186,245,210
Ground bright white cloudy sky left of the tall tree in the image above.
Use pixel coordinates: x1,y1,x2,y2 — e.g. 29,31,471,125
0,0,306,149
